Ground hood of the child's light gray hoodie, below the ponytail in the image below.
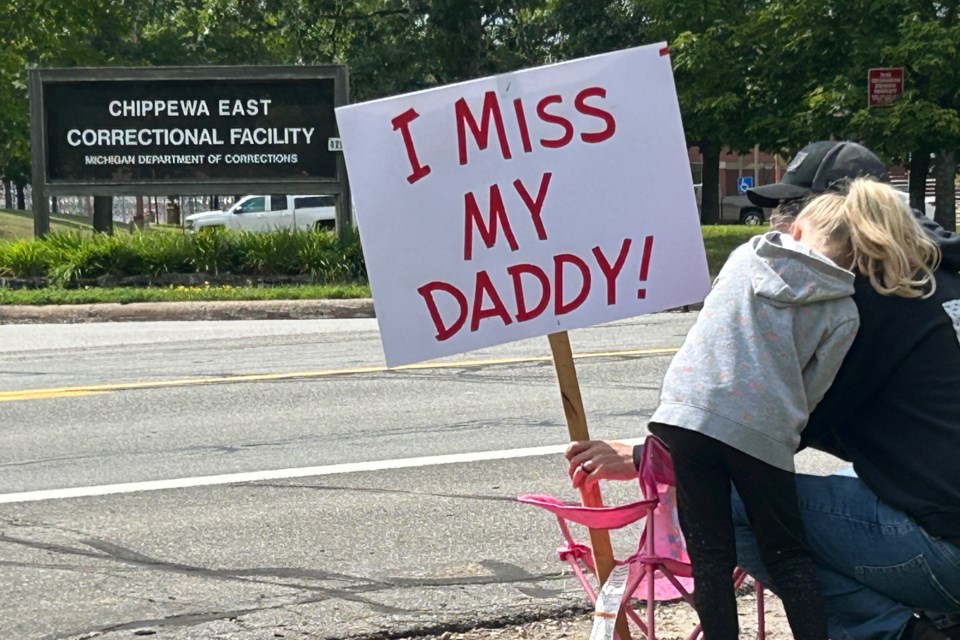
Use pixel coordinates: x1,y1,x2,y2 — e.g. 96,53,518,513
748,231,854,306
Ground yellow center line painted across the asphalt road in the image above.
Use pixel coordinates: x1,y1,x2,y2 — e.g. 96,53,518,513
0,348,677,402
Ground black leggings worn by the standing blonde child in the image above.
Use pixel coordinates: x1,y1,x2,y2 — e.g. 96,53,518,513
649,422,827,640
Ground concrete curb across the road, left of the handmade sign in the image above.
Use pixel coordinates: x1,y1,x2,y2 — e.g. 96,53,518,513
0,298,376,324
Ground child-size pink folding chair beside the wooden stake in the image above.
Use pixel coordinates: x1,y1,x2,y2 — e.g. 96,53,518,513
517,436,765,640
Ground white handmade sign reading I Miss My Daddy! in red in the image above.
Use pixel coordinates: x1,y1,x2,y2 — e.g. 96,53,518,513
336,44,710,366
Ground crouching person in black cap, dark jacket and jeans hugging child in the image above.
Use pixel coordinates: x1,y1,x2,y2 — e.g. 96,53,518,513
567,141,960,640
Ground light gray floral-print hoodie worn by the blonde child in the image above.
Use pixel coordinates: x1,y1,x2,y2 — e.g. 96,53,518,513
651,232,860,471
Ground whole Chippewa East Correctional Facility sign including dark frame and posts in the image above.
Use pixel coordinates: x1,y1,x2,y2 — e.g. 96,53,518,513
30,65,349,234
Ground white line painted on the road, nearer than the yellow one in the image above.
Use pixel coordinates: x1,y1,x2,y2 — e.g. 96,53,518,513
0,438,644,504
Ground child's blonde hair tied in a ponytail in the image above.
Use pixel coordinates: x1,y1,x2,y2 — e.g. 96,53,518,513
797,178,940,298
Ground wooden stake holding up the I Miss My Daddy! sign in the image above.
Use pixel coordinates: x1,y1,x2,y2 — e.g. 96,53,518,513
547,331,630,640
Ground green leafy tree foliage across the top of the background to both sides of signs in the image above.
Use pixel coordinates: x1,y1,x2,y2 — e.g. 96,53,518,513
0,0,960,221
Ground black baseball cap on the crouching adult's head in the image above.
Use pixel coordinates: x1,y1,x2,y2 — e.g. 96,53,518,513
747,140,889,208
